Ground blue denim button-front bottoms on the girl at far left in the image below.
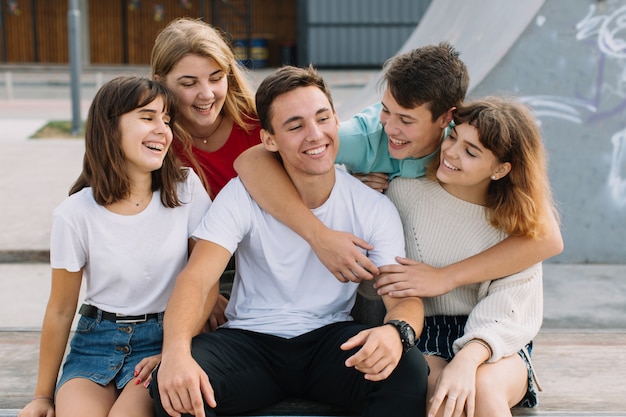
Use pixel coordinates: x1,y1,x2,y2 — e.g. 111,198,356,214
57,313,163,390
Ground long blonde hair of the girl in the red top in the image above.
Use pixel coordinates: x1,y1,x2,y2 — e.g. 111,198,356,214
150,18,258,190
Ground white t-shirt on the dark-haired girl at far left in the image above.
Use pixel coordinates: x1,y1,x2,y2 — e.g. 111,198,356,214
50,169,211,315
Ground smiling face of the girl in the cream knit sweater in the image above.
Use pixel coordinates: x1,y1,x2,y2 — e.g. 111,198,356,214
437,123,511,205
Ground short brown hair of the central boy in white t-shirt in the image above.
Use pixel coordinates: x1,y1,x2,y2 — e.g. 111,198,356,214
256,65,334,134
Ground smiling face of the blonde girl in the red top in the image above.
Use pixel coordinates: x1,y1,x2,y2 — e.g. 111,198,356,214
161,55,228,137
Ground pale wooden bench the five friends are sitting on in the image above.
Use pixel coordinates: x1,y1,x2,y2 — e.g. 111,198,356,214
0,329,626,417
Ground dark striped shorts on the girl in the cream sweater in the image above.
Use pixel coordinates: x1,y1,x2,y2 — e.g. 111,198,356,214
416,315,541,408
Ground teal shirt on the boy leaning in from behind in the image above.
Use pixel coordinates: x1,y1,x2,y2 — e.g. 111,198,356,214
335,103,450,180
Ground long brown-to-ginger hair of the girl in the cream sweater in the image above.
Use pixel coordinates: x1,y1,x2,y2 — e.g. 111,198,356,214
429,97,558,239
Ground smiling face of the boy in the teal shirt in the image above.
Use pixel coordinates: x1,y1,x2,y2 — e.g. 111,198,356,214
380,89,452,159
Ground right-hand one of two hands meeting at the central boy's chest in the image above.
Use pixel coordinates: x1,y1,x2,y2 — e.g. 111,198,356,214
374,256,455,297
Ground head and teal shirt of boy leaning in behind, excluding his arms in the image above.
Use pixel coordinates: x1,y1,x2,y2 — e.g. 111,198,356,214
336,43,469,180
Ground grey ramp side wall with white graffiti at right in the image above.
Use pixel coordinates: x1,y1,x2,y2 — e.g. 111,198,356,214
470,0,626,263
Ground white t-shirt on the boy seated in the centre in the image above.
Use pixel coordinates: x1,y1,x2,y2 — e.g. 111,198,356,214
194,169,404,338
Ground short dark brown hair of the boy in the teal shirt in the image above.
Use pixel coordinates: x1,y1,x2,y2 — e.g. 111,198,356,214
383,42,469,121
